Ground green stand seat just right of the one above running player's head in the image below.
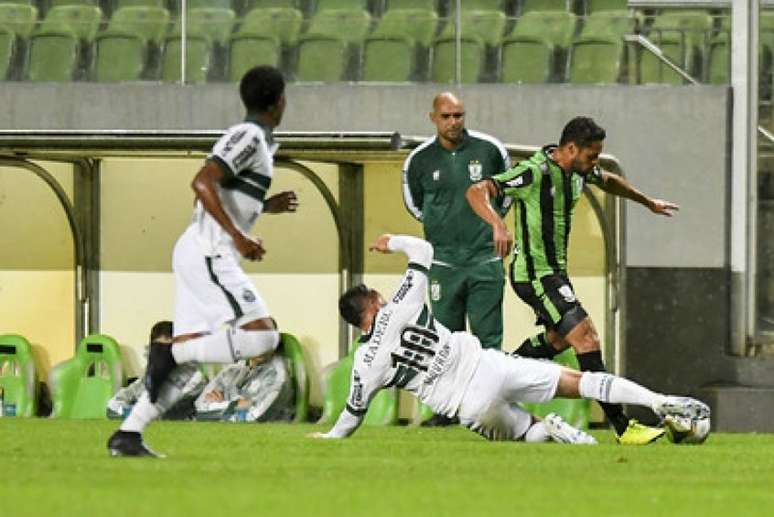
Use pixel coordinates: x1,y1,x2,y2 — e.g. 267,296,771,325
296,34,349,83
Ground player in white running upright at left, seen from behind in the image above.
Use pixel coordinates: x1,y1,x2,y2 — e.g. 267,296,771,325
108,66,298,456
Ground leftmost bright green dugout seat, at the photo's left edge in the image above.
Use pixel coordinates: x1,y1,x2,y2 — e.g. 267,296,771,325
0,334,38,416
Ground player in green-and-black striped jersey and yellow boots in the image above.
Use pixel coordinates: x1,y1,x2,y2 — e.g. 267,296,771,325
466,117,679,445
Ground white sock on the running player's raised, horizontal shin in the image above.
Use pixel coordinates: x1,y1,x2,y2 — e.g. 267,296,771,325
172,327,279,364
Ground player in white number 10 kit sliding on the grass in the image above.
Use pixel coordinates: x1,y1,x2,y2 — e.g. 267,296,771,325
311,235,709,444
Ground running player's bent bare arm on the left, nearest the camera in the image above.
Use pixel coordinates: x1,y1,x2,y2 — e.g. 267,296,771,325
191,160,266,260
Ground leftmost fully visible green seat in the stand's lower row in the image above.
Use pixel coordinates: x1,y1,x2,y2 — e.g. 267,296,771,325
27,30,78,82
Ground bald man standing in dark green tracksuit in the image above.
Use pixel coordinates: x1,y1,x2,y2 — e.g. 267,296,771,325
403,92,511,425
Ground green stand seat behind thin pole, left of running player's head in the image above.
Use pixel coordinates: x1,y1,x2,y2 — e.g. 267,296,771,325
161,33,212,84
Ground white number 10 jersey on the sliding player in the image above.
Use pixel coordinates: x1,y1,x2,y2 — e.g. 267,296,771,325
329,236,481,437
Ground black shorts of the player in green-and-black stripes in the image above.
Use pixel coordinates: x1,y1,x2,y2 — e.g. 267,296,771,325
509,270,588,337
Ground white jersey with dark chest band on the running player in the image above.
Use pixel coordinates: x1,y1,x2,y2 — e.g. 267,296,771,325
191,121,278,256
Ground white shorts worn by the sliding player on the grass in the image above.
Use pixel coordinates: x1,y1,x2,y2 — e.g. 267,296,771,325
457,349,562,440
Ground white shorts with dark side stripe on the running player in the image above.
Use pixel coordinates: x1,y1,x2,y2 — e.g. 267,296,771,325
172,227,269,336
